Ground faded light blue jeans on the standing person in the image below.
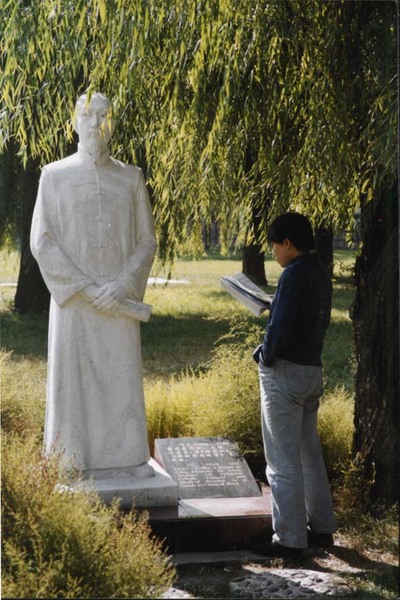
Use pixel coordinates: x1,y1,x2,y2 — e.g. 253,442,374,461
259,359,336,548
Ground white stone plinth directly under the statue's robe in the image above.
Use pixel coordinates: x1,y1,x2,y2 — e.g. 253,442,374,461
77,459,178,509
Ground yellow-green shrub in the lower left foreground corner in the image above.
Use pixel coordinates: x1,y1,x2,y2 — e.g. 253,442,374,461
2,434,174,598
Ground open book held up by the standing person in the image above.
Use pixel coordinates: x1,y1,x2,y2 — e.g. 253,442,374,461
220,273,273,317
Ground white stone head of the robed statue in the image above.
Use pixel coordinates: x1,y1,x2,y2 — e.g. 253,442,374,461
74,92,114,154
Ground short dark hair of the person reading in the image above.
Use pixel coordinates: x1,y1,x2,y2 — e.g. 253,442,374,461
267,212,315,252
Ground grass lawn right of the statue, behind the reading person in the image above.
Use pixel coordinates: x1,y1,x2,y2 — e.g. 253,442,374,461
146,251,354,390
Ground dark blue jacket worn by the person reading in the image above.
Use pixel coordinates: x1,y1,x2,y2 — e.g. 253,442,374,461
254,254,332,366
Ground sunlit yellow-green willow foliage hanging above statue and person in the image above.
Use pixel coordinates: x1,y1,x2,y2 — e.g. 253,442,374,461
0,0,357,257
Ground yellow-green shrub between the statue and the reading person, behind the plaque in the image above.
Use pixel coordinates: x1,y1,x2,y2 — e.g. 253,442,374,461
146,320,262,456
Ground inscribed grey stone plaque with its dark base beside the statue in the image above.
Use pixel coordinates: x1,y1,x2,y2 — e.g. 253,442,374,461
148,437,272,554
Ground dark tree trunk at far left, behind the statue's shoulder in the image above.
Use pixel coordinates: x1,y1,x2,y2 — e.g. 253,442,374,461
14,162,50,313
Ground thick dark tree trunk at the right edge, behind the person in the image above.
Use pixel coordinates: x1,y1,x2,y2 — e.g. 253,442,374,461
352,185,400,502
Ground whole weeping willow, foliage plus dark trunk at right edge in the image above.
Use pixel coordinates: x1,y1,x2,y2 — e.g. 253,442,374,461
0,0,399,497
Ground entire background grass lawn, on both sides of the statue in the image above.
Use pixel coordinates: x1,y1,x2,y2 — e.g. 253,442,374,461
0,251,354,390
